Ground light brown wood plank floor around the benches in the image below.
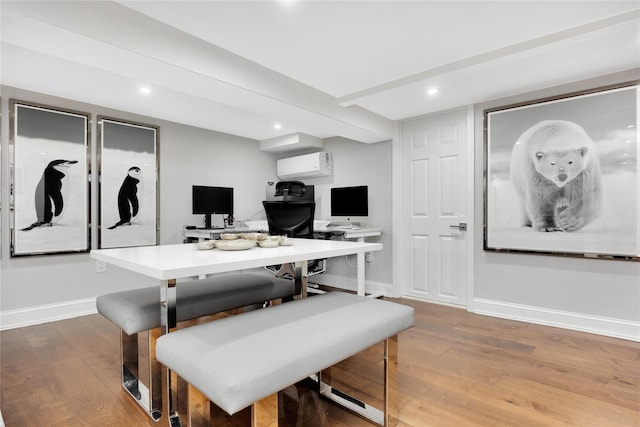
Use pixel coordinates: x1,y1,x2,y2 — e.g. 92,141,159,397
0,300,640,427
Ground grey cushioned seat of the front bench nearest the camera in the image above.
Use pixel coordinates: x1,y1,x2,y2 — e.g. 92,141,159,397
156,292,414,414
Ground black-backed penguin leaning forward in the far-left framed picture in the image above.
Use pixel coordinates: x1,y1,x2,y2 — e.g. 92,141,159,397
22,159,78,231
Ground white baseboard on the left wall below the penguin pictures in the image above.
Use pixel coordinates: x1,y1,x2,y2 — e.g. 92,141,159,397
0,298,97,332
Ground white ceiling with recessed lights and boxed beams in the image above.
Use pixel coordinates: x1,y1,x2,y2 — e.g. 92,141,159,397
0,0,640,143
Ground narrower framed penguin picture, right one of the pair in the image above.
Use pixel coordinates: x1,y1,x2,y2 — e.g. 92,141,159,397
98,117,159,248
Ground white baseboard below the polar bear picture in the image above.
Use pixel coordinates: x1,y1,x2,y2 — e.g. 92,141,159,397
473,298,640,342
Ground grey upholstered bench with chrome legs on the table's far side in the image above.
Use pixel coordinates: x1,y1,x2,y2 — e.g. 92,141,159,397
96,273,294,420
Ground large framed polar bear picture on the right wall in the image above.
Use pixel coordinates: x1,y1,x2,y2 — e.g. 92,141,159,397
484,82,640,261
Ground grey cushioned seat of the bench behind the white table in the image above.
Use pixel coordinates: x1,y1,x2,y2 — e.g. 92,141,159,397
96,273,294,335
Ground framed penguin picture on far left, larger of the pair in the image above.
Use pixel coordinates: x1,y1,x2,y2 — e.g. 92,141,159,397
10,99,90,256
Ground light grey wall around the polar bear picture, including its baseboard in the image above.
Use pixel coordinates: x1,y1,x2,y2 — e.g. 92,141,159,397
474,70,640,340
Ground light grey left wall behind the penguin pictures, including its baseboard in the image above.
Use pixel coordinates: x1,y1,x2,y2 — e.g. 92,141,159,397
0,87,275,327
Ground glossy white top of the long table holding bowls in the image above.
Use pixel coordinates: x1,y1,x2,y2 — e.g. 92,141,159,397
91,239,382,280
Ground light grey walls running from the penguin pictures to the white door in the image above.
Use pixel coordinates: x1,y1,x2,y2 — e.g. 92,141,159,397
0,86,391,328
